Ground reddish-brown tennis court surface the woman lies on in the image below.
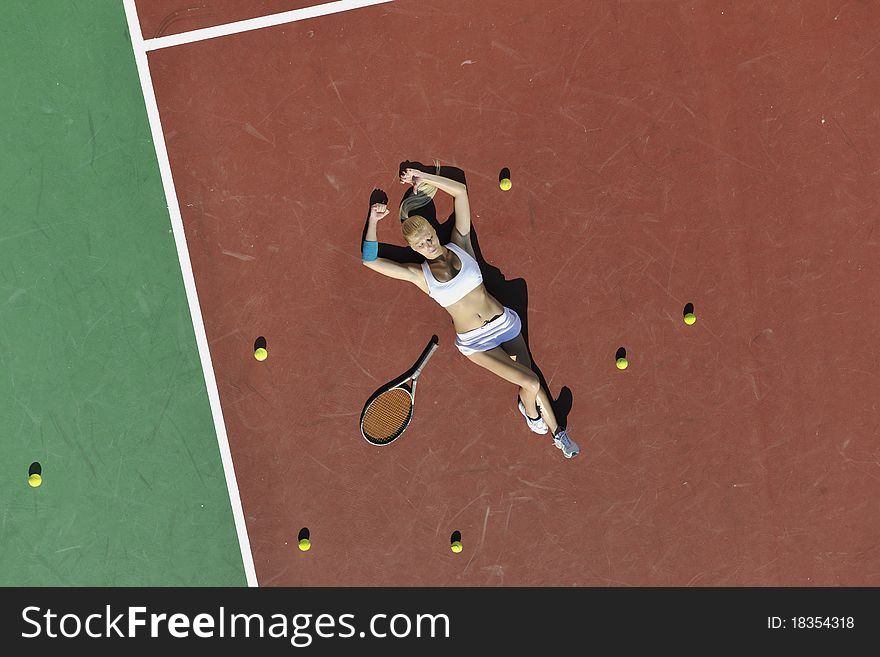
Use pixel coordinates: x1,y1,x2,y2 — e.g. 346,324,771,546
139,0,880,586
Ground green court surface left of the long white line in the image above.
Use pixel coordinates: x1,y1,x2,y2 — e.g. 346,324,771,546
0,0,246,586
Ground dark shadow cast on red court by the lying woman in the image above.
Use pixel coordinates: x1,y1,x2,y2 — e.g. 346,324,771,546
364,160,573,427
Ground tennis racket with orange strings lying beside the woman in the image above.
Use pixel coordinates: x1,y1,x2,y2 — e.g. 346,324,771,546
361,335,438,445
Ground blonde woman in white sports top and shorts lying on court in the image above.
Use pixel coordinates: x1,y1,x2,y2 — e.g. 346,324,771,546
362,168,580,458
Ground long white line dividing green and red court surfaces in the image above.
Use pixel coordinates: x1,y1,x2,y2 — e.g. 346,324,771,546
123,0,257,586
